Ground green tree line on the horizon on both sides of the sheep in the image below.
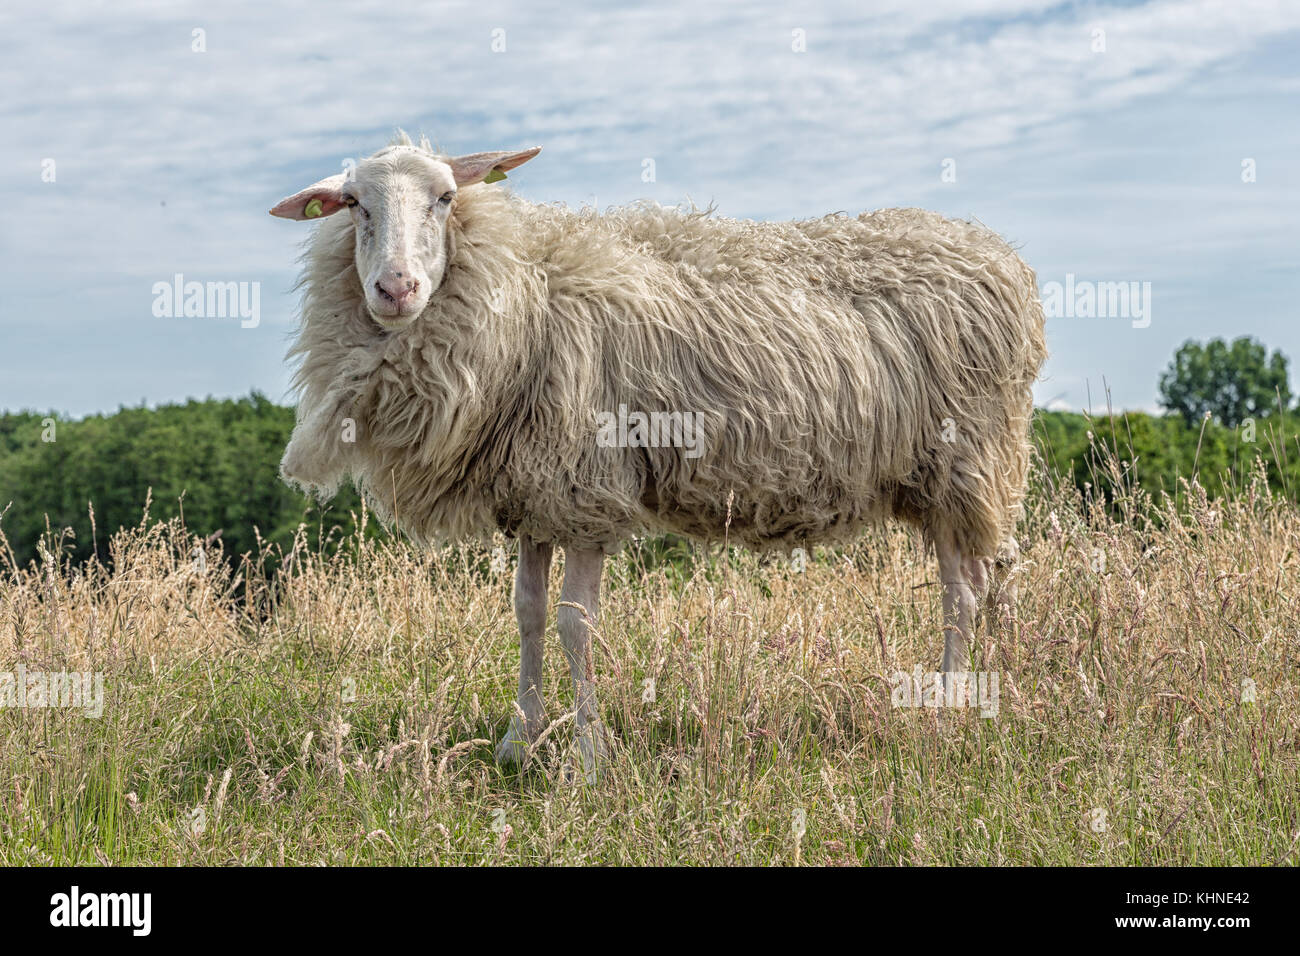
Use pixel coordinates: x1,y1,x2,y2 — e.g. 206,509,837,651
0,339,1300,564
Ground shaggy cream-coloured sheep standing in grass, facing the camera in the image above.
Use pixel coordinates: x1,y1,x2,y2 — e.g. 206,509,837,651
270,134,1047,779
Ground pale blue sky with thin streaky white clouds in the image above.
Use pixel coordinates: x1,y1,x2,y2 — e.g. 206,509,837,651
0,0,1300,416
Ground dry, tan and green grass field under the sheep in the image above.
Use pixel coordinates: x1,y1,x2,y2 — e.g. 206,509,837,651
0,455,1300,865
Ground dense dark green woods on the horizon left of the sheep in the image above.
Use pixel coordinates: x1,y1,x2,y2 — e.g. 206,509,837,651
0,393,360,564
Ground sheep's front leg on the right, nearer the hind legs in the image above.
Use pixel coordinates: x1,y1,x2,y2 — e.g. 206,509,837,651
558,548,610,783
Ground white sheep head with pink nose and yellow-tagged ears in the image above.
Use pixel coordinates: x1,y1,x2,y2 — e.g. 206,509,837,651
270,146,541,329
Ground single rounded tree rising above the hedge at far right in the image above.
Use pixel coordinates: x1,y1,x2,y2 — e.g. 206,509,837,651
1160,336,1291,428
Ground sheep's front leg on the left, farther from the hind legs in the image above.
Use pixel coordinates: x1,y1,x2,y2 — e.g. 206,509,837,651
497,537,553,765
